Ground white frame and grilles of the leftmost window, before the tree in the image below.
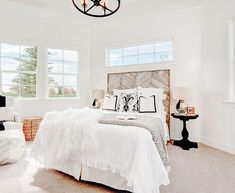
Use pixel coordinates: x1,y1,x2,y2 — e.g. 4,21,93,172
0,42,38,100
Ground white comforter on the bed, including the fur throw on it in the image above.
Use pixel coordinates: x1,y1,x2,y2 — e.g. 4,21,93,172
32,108,169,193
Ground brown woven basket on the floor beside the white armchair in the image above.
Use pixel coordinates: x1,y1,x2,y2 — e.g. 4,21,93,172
23,117,43,141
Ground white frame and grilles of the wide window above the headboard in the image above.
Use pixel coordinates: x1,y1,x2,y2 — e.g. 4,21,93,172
105,38,175,68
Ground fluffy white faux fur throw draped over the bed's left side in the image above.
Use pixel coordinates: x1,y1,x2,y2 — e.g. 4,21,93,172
31,108,101,162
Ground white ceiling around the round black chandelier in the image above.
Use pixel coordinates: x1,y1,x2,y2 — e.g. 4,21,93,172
0,0,201,27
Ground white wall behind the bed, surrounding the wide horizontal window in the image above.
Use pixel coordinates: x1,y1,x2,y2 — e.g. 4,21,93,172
90,6,202,141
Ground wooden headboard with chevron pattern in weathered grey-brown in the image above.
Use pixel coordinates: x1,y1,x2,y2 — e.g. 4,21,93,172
107,70,170,128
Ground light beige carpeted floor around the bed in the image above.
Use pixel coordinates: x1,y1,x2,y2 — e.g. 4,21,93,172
0,145,235,193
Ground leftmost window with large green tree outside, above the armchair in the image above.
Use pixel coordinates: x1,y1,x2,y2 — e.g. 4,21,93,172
0,43,37,98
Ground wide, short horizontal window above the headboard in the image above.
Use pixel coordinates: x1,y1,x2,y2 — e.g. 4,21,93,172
107,41,173,66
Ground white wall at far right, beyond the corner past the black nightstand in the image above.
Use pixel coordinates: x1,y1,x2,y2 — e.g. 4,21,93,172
202,0,235,153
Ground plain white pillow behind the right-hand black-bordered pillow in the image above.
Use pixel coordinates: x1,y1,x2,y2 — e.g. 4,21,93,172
137,86,166,113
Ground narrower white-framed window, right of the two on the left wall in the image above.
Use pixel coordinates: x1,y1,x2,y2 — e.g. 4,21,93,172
48,49,78,97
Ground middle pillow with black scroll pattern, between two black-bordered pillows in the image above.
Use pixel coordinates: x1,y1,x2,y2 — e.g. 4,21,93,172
119,93,138,113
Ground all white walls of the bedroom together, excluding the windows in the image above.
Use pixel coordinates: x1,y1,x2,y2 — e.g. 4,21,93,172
0,0,235,153
